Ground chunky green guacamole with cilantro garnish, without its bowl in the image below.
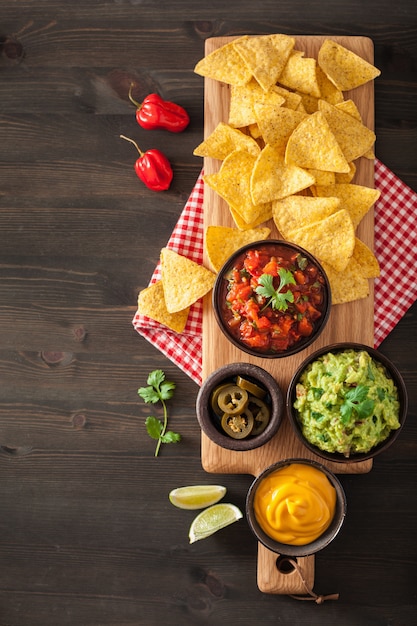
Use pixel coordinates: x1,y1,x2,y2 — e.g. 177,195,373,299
294,350,400,457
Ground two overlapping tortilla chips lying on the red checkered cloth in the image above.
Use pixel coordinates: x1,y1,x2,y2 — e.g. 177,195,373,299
138,248,216,333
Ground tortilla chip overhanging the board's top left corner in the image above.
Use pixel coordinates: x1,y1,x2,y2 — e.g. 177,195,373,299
194,35,252,85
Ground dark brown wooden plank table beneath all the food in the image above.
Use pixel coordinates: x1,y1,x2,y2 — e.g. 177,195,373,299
0,0,417,626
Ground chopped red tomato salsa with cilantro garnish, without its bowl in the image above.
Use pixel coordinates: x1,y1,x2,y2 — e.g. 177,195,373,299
223,244,326,353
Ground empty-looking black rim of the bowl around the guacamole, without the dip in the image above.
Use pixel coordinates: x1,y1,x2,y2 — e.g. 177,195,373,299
286,342,408,463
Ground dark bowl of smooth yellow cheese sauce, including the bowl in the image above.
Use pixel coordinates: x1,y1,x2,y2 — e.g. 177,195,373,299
246,458,346,557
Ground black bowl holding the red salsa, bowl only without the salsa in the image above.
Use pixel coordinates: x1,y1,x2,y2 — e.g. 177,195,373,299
212,239,331,359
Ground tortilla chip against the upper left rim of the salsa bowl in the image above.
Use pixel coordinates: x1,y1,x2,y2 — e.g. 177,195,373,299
205,226,271,272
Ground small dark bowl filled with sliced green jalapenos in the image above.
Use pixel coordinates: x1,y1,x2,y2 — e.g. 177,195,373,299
196,363,284,451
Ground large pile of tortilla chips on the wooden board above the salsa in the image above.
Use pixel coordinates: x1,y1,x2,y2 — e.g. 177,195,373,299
194,34,380,304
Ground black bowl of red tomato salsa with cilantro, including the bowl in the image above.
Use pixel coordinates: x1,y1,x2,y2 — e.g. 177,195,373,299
212,239,331,358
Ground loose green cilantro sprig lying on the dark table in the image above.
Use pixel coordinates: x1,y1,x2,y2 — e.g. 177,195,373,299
138,370,181,456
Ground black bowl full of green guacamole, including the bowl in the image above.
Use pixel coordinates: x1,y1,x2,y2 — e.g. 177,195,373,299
286,342,408,463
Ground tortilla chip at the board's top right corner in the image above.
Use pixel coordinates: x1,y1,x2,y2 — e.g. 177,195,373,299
318,39,381,91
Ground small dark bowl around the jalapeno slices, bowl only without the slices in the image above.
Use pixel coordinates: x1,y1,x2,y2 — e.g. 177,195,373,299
196,363,285,451
